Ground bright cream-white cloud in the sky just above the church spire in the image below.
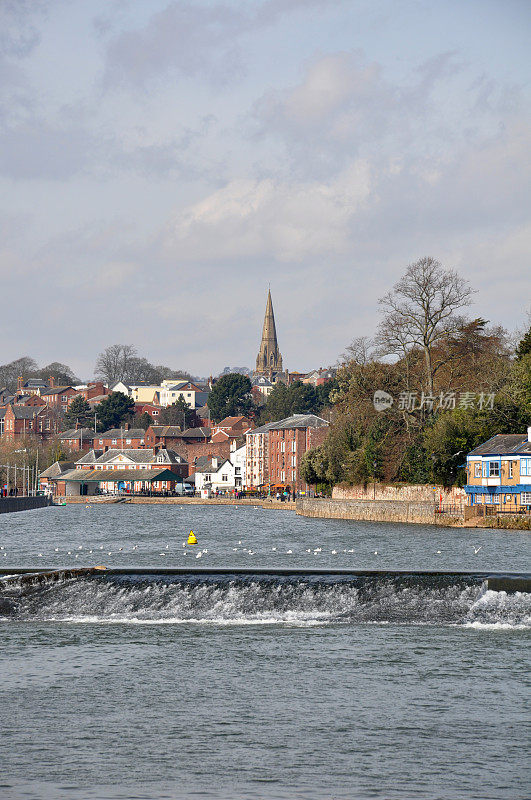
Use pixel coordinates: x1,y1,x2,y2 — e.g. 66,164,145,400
162,161,371,263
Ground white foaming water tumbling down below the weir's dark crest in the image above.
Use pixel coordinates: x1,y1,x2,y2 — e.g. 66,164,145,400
2,578,531,629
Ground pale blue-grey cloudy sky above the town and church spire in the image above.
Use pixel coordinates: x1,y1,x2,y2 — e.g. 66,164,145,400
0,0,531,379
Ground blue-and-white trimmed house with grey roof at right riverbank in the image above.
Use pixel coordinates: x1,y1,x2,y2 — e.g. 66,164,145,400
465,426,531,513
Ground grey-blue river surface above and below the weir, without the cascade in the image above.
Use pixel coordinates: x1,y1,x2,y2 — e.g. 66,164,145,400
0,505,531,800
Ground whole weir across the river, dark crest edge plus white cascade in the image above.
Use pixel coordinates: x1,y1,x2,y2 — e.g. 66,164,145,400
0,568,531,628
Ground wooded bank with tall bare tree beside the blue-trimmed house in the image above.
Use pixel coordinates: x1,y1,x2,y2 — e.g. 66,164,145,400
302,259,531,486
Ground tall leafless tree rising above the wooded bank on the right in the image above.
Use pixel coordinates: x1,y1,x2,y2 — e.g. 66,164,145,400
377,257,472,395
